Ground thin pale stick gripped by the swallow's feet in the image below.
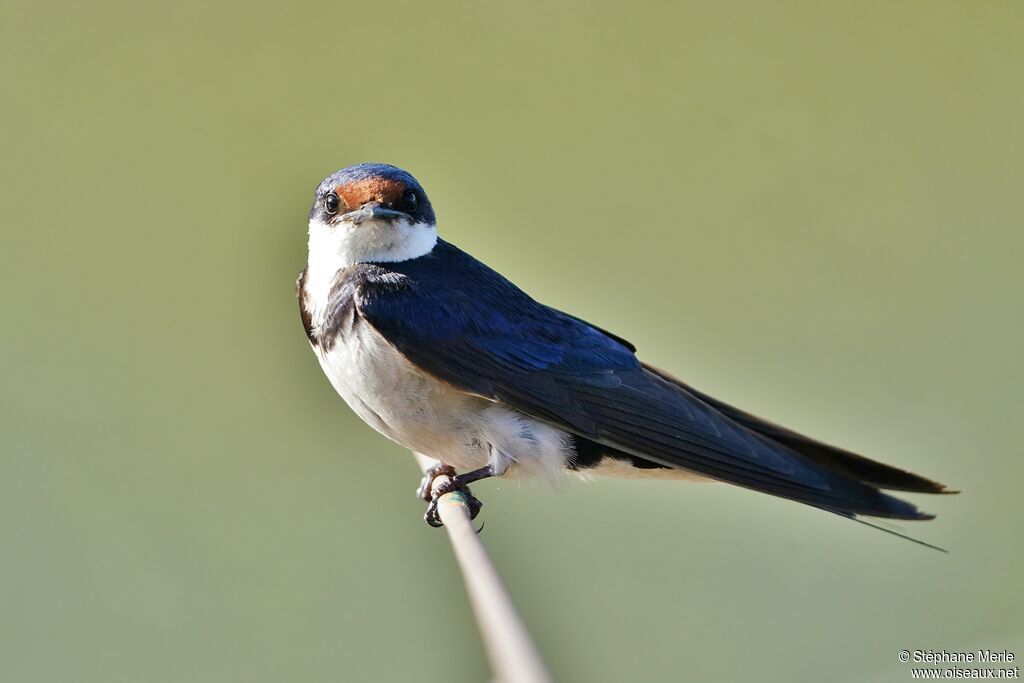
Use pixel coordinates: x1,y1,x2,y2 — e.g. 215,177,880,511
413,453,551,683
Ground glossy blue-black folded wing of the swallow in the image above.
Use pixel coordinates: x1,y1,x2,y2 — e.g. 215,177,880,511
355,242,930,519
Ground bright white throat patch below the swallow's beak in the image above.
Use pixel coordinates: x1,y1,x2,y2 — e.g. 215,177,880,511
306,219,437,321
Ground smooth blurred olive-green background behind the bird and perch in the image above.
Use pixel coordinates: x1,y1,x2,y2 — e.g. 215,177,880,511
0,0,1024,682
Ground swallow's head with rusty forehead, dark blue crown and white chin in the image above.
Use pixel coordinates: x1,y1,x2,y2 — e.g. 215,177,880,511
309,164,437,269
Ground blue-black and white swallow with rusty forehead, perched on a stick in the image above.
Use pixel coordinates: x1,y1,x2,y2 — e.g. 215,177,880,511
297,164,954,545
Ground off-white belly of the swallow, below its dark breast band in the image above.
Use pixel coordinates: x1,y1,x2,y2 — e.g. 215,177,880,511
313,321,569,478
